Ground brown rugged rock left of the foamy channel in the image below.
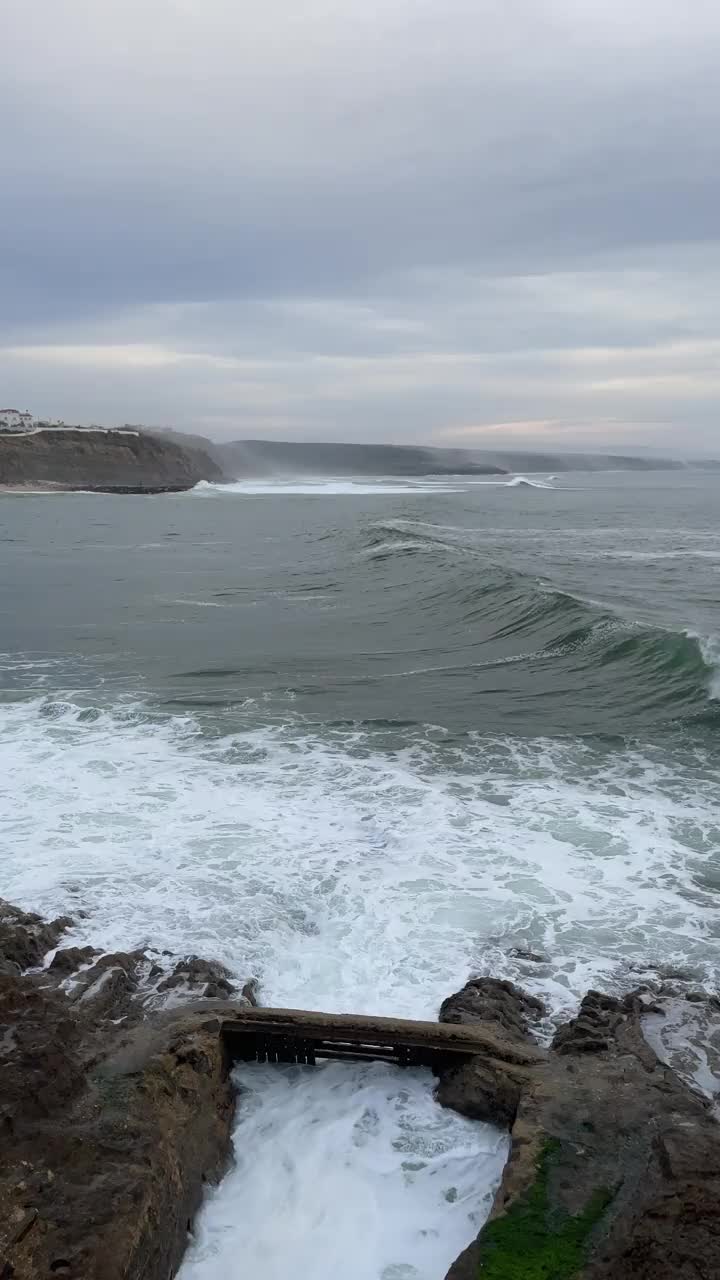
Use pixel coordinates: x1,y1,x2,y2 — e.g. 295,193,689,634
0,904,254,1280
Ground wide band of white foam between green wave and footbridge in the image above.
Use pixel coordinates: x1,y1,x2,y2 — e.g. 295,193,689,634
0,700,720,1016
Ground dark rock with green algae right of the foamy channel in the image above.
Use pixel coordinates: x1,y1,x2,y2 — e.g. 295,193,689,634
438,984,720,1280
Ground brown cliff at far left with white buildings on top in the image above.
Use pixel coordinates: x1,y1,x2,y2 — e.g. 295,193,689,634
0,428,223,493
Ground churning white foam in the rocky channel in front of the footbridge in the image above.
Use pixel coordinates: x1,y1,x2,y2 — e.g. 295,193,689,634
181,1064,507,1280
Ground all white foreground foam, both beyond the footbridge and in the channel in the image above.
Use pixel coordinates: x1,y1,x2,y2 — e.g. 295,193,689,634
0,700,720,1280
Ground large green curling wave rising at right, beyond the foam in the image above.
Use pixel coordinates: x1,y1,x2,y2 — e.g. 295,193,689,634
361,520,720,719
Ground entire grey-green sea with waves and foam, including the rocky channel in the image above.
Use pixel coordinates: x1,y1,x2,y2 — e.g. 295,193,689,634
0,472,720,1280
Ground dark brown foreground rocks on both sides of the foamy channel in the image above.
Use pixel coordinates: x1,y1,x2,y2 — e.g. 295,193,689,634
0,900,720,1280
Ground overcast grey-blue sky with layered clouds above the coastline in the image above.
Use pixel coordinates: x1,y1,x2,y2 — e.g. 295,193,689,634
0,0,720,454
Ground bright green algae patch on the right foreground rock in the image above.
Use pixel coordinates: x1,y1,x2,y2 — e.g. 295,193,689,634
478,1140,615,1280
